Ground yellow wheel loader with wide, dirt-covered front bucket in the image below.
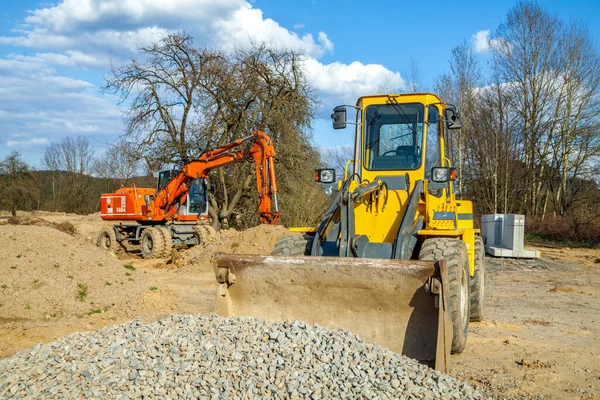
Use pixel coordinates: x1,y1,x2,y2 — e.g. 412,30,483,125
215,93,485,371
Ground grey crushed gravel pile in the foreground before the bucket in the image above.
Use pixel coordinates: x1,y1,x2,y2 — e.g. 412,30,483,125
0,315,483,399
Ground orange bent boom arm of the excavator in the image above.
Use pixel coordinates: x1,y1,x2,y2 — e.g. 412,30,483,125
154,131,281,225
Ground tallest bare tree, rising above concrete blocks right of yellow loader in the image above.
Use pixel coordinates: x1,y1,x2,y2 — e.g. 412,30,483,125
492,1,563,215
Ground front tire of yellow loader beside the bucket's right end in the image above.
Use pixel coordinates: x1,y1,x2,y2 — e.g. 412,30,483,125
419,238,471,354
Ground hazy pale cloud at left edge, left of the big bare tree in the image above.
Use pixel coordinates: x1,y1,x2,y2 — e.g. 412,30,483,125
0,56,122,163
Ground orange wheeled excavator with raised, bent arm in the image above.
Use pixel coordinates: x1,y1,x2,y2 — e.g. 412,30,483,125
97,131,281,258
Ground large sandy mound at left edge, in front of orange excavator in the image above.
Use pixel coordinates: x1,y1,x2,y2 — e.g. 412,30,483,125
0,225,148,321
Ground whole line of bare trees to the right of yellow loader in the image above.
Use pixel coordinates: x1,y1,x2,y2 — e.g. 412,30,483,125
435,1,600,241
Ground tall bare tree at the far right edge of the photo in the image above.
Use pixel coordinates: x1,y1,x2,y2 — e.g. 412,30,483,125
544,21,600,215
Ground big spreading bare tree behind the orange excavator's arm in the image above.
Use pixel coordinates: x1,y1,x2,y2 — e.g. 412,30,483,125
104,34,326,227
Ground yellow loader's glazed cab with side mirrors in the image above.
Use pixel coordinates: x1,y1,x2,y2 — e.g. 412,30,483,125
331,93,462,189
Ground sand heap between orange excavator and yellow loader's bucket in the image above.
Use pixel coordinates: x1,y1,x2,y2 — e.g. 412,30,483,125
173,225,291,271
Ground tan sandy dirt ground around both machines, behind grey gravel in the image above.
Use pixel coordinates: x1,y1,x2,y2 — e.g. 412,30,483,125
0,213,600,399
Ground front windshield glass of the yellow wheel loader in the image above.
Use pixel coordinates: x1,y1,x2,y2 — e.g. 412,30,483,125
364,104,424,170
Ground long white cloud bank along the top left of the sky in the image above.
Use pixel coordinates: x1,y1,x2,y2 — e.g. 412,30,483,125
0,0,333,62
